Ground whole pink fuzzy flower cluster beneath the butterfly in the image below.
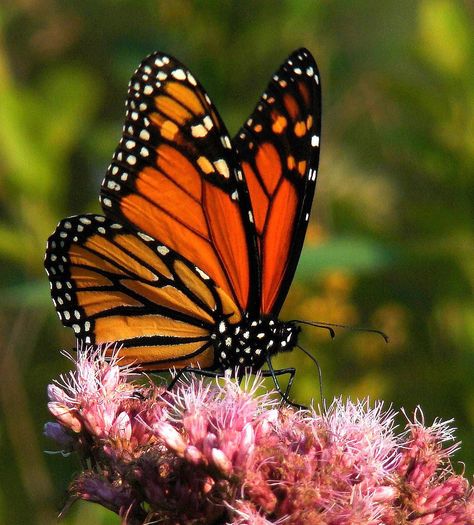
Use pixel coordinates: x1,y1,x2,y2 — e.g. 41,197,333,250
45,349,474,525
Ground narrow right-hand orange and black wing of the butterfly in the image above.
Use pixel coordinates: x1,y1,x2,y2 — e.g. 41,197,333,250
233,49,321,315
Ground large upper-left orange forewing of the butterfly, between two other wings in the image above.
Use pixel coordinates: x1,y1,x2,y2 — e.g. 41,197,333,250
101,53,260,311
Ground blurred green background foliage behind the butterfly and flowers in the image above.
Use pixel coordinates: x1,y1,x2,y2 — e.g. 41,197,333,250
0,0,474,525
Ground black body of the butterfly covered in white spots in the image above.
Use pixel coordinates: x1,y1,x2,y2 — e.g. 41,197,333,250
211,316,300,370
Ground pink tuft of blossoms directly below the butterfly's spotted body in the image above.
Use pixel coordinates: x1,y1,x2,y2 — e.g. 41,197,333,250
155,368,275,478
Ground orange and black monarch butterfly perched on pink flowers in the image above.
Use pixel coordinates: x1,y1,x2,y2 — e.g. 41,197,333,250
45,49,321,371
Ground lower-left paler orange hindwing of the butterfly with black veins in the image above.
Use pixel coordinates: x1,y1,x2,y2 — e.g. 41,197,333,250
45,215,240,370
